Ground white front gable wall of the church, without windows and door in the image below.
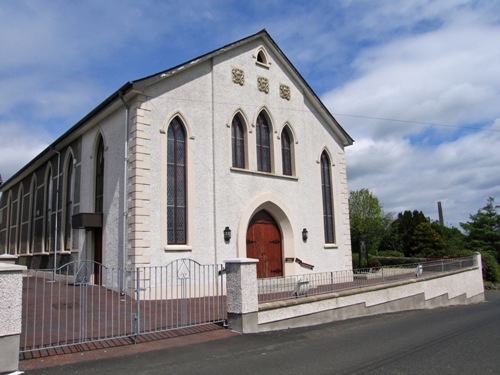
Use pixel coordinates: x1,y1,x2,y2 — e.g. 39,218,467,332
137,36,351,274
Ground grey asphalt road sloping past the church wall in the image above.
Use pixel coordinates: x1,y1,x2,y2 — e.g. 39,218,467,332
27,292,500,375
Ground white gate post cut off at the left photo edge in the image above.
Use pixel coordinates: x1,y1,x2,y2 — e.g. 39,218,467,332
0,263,26,374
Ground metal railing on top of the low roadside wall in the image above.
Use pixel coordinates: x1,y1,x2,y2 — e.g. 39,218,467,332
258,256,477,303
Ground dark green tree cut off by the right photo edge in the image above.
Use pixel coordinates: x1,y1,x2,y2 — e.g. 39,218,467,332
460,197,500,262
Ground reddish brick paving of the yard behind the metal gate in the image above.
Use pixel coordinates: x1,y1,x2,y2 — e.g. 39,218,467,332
21,273,226,360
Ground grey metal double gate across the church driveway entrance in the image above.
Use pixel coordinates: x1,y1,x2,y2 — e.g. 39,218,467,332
20,259,226,352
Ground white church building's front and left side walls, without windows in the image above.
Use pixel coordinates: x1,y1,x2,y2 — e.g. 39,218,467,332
0,31,353,275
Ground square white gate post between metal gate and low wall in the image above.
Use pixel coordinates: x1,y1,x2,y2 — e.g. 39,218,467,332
224,258,259,333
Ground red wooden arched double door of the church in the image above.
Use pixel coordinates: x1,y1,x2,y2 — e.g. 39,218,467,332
247,210,283,278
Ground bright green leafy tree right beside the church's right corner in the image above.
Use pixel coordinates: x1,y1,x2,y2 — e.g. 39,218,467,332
349,189,385,253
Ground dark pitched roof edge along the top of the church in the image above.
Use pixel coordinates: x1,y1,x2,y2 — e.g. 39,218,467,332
0,29,354,190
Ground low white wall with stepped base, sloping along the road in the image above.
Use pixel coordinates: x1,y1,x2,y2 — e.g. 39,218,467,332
227,254,484,333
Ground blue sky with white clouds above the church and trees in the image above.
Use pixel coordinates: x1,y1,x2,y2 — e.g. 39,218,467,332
0,0,500,228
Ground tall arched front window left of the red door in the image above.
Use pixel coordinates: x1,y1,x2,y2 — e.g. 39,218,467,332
167,117,187,244
